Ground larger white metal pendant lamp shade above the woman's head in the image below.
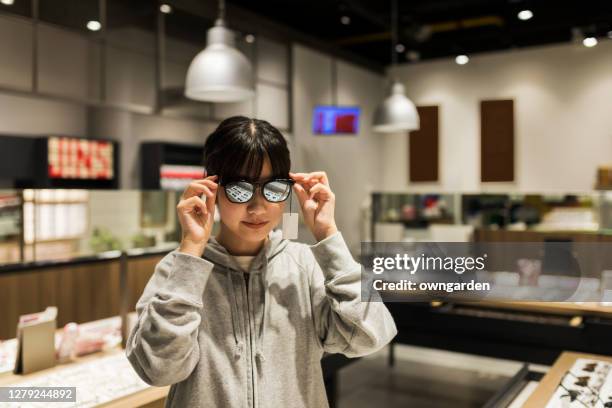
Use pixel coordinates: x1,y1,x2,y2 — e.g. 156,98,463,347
185,19,255,102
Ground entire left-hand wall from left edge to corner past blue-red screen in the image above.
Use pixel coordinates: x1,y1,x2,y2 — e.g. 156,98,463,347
0,15,384,251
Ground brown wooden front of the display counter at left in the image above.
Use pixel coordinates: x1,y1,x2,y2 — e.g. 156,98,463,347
0,245,176,340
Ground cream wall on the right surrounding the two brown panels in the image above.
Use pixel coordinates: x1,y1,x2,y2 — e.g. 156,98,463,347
383,40,612,192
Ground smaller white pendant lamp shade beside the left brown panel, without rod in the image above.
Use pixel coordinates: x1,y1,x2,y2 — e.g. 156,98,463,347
373,81,420,133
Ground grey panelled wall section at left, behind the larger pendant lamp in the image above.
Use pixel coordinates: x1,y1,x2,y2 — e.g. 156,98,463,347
0,14,290,189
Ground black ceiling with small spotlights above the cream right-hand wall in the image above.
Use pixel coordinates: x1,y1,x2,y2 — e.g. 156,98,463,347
228,0,612,65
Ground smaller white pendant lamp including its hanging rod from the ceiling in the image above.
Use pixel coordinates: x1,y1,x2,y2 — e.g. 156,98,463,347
372,0,420,133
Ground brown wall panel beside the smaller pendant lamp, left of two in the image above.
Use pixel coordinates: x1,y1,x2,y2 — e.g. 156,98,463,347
408,106,439,182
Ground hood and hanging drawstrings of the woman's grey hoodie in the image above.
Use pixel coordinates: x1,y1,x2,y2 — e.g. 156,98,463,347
203,230,289,363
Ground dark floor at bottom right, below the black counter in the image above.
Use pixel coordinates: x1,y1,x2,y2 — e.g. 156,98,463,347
339,352,510,408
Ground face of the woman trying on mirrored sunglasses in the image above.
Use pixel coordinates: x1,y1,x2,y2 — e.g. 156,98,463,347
217,157,286,244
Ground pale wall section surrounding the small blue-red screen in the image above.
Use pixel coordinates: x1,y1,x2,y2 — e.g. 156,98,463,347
291,45,384,253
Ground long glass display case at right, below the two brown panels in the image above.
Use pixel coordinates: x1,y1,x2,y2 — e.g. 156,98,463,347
370,191,612,241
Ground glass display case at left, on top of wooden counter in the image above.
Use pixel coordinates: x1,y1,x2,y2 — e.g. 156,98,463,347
0,189,180,265
